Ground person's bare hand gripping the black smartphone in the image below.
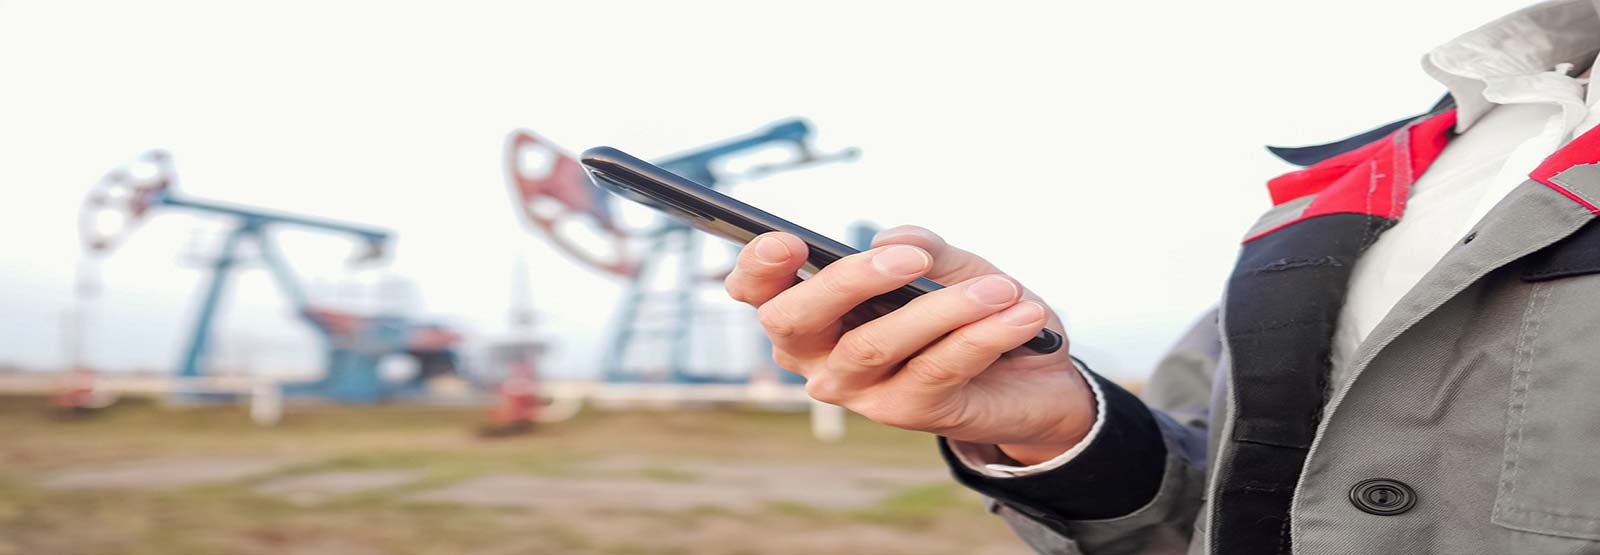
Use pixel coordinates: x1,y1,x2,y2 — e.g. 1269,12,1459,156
726,226,1094,464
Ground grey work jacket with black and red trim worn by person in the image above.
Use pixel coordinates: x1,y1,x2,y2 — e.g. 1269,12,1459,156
941,103,1600,555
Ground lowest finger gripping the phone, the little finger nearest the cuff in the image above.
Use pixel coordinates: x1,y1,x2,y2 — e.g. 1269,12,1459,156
890,301,1048,392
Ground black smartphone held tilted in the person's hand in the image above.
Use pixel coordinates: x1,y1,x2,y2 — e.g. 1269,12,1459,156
581,147,1062,353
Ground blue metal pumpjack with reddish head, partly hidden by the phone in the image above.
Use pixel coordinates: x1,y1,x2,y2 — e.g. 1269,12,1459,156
507,118,858,384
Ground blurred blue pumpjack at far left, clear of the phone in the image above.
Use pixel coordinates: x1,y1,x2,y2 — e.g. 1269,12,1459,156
83,150,459,403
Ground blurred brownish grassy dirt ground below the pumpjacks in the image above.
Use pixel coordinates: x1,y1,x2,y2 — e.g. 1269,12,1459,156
0,398,1027,555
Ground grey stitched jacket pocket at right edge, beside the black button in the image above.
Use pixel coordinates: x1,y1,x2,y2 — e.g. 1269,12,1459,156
1491,279,1600,541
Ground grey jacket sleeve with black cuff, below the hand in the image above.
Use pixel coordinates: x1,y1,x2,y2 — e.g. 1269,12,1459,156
939,310,1221,555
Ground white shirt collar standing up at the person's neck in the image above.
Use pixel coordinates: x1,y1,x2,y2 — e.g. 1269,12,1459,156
1422,0,1600,131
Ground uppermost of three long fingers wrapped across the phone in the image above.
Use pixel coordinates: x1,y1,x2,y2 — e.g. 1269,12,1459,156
758,245,933,353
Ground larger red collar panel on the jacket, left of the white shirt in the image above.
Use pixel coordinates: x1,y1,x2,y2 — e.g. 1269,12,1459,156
1245,110,1465,243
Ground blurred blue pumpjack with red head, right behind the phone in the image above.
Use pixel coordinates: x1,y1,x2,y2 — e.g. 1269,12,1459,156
506,118,858,385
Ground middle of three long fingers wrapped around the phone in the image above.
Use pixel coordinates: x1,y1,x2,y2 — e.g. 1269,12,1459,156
827,274,1026,389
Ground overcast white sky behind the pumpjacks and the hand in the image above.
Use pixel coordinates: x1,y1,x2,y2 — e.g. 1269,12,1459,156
0,0,1526,376
